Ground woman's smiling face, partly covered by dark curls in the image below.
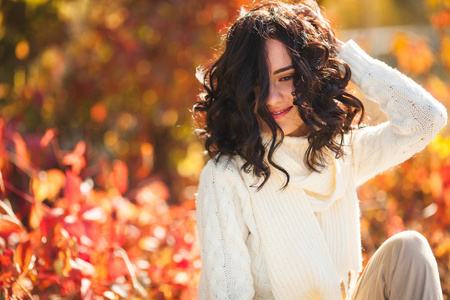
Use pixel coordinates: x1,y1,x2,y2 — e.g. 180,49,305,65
255,40,308,136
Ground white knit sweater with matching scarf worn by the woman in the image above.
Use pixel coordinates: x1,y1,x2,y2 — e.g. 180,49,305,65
197,41,447,300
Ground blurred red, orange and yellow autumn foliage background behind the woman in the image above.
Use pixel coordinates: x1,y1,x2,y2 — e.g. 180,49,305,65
0,0,450,299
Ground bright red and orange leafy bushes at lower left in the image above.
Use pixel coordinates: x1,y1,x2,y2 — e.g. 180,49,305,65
0,120,200,299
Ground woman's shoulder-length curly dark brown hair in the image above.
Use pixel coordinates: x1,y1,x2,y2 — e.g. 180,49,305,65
193,0,364,189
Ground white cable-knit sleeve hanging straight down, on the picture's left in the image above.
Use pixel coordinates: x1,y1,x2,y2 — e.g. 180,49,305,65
197,159,254,300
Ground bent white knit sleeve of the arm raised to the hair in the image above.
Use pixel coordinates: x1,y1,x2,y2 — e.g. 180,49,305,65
339,41,447,185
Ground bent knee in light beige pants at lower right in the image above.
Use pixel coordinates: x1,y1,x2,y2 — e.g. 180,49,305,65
351,231,443,300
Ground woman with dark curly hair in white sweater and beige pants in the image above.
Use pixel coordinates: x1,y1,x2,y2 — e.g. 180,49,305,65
194,2,447,300
